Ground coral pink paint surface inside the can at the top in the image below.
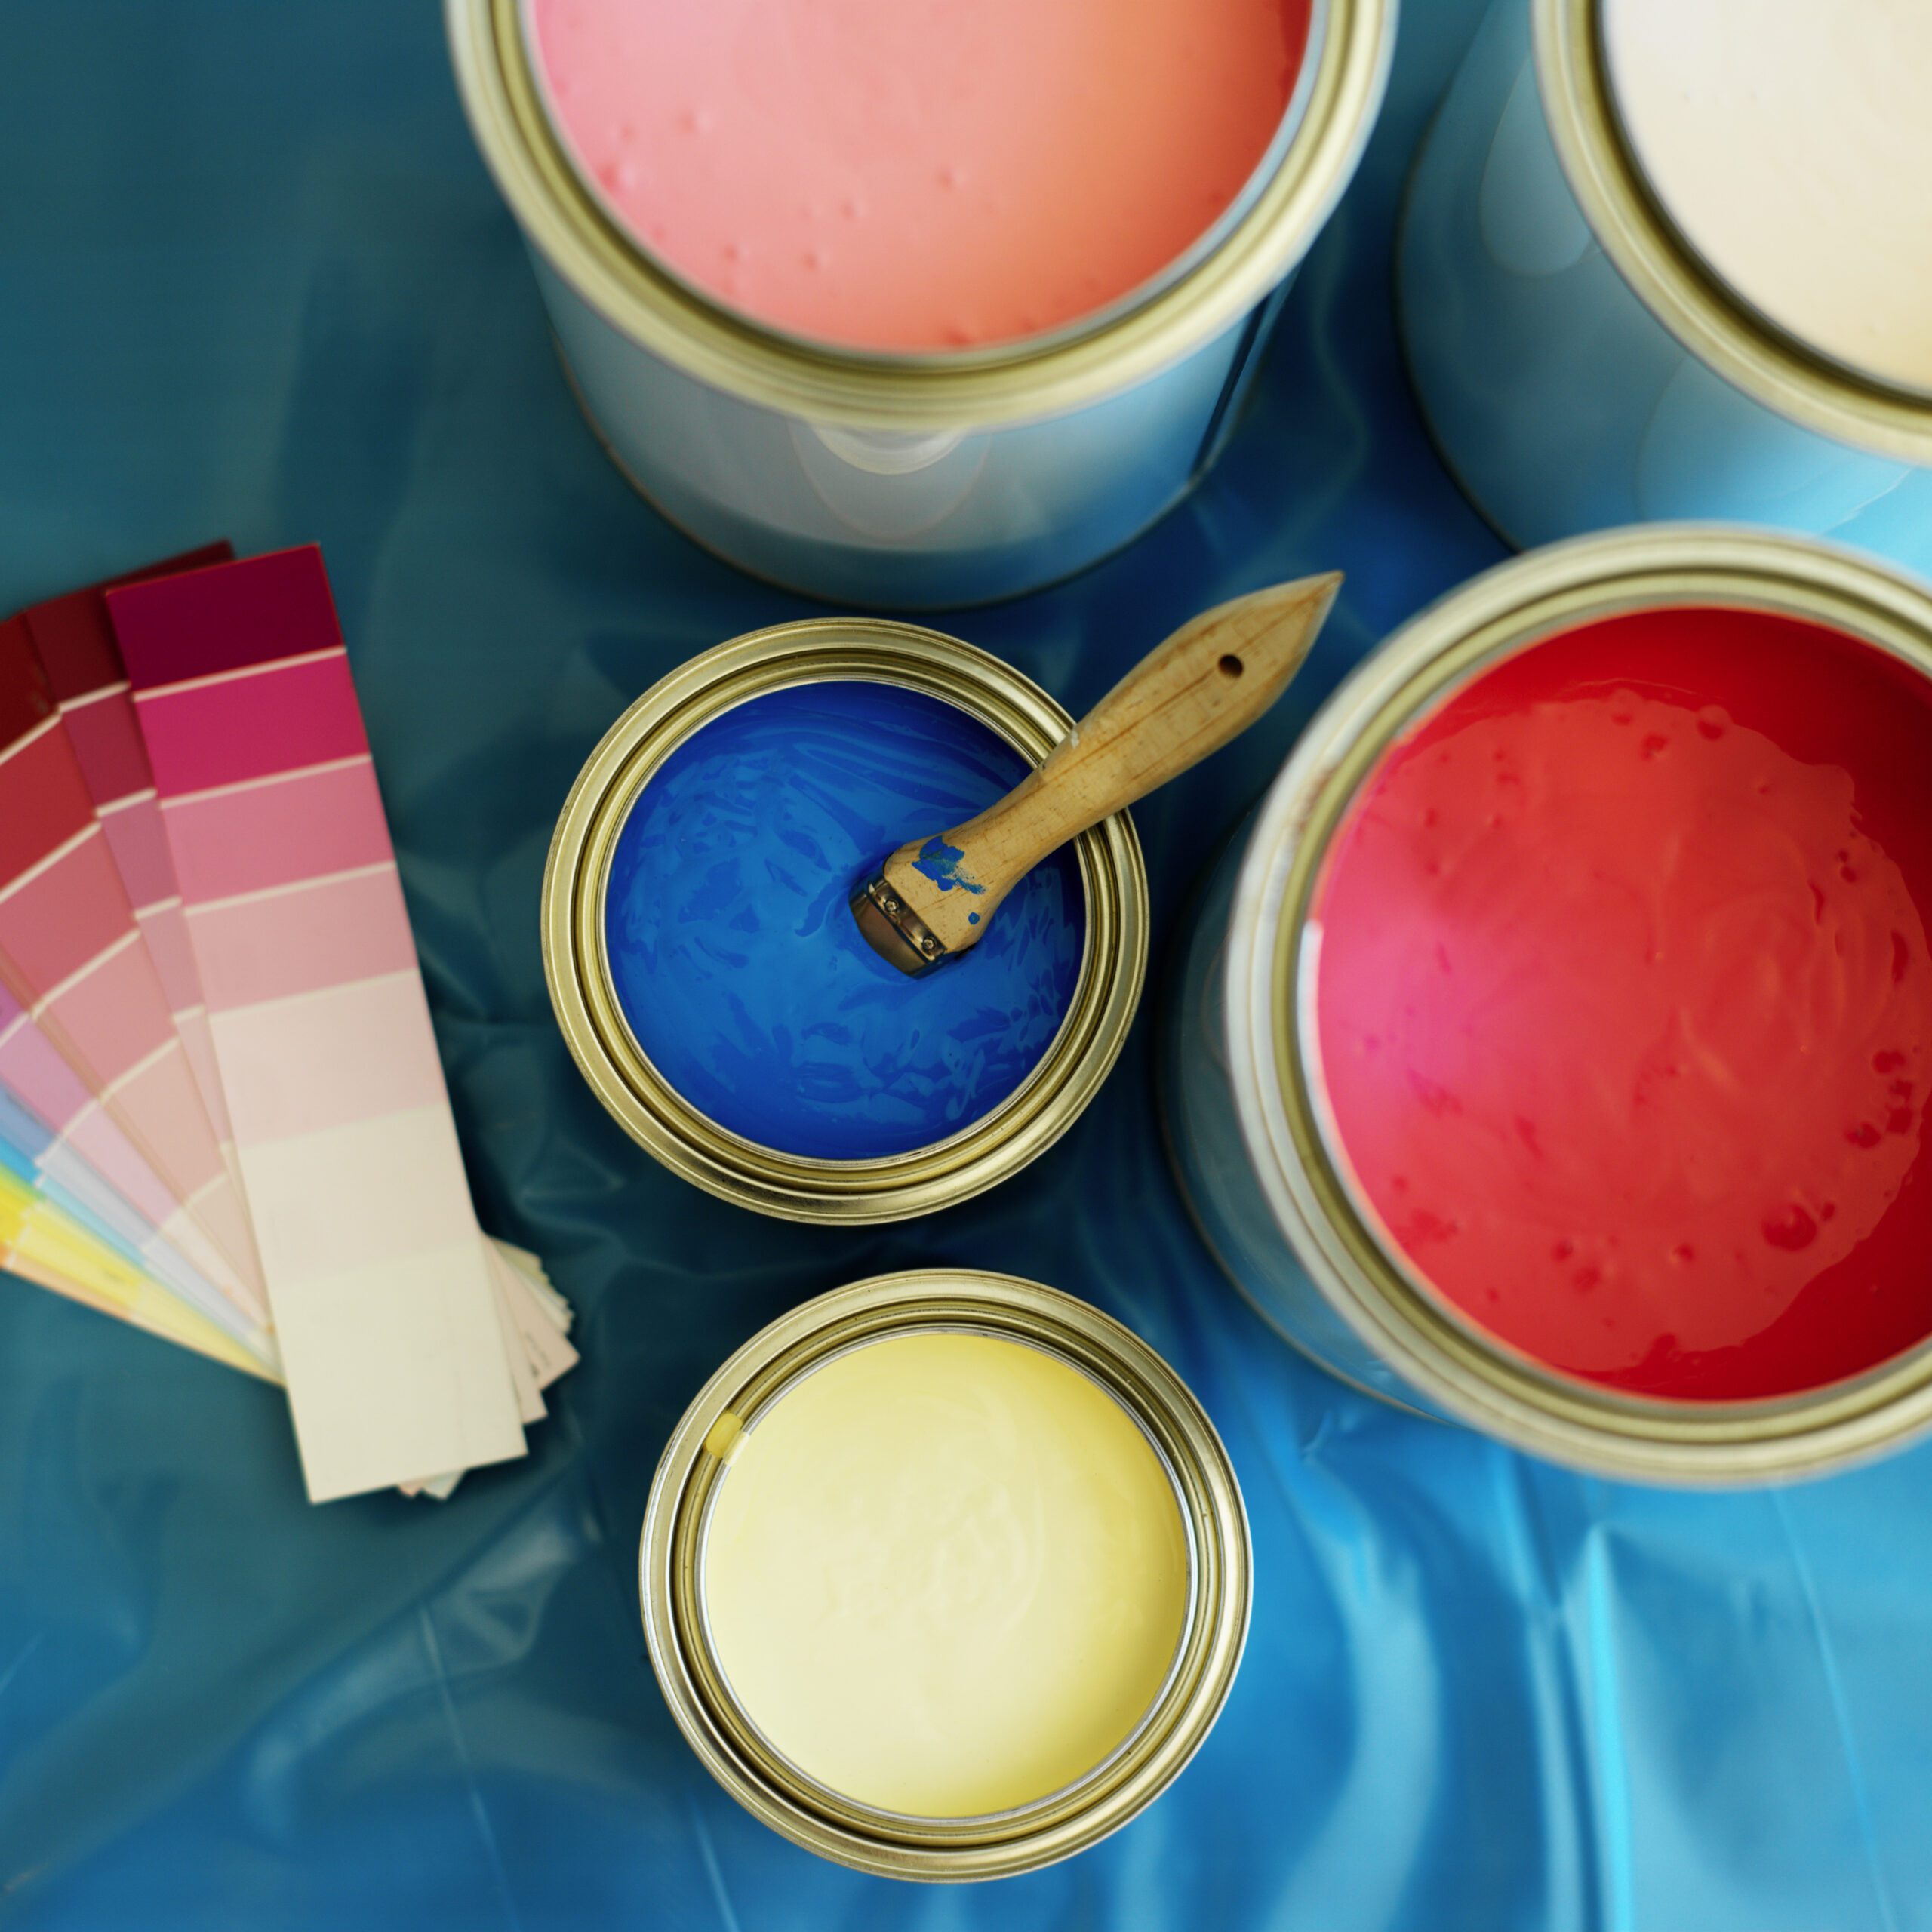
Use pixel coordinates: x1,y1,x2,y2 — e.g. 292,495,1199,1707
528,0,1310,349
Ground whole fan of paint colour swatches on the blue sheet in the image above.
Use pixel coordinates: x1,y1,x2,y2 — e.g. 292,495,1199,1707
0,545,576,1501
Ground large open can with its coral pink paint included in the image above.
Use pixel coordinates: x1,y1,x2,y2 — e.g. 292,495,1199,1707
446,0,1395,608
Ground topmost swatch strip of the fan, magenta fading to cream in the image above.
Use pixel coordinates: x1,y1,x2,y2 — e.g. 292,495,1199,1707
106,549,529,1501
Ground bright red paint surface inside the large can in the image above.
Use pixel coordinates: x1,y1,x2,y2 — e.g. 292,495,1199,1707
1315,608,1932,1401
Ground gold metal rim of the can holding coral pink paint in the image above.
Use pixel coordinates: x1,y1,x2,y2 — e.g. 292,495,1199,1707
445,0,1397,431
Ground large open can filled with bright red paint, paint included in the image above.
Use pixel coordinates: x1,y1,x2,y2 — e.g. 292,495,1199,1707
1165,525,1932,1484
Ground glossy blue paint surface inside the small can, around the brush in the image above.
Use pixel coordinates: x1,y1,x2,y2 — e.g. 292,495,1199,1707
605,680,1086,1161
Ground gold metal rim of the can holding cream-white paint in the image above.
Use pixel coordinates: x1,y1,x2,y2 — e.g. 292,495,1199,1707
1531,0,1932,463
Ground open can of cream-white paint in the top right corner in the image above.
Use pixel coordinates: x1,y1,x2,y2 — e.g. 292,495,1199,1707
1397,0,1932,570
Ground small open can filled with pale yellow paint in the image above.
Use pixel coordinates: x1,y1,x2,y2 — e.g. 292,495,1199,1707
639,1269,1250,1880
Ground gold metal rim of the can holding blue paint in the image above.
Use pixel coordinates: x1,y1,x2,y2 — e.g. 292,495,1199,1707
543,618,1148,1223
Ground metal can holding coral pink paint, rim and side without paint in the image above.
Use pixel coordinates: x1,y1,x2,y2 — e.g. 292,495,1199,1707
446,0,1395,608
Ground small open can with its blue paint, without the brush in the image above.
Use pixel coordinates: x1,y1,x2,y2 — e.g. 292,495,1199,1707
543,618,1148,1221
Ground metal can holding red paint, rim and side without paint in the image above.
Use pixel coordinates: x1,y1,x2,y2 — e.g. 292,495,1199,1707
1163,524,1932,1486
